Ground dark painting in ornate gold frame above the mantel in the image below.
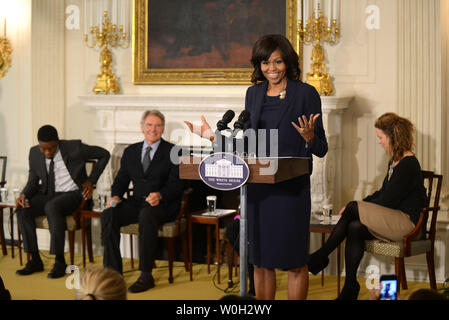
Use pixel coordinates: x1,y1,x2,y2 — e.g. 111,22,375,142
132,0,302,84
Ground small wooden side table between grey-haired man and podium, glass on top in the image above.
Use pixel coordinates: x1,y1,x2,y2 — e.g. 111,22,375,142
188,209,237,283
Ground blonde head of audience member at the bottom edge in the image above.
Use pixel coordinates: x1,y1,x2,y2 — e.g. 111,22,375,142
75,268,127,300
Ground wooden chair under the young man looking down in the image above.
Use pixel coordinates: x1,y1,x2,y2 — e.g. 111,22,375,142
19,160,96,265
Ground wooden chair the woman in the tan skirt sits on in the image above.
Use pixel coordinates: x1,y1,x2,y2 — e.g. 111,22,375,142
365,171,443,291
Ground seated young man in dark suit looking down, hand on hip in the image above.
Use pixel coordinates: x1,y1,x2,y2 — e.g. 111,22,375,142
16,125,110,278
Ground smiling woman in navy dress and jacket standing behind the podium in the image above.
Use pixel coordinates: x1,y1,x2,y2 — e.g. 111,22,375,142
185,35,328,300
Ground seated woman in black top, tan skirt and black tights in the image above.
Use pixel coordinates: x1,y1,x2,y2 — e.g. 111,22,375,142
308,113,428,300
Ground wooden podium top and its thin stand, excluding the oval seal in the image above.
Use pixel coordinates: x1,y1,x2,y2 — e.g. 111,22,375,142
179,156,310,296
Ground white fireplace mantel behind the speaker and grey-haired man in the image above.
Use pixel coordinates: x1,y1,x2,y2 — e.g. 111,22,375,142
79,95,351,211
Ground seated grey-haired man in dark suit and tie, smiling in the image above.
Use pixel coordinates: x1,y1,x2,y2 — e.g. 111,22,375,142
101,110,184,293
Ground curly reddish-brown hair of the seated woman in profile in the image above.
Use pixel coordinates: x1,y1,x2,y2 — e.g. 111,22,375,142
374,112,414,161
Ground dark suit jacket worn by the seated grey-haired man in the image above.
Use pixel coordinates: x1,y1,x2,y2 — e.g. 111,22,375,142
111,139,184,218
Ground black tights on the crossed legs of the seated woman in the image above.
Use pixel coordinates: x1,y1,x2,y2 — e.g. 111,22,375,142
319,201,374,284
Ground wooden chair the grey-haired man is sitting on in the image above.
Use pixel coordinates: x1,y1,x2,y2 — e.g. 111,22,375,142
120,188,192,283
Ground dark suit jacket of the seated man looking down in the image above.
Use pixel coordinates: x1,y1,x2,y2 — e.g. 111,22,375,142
22,140,110,198
